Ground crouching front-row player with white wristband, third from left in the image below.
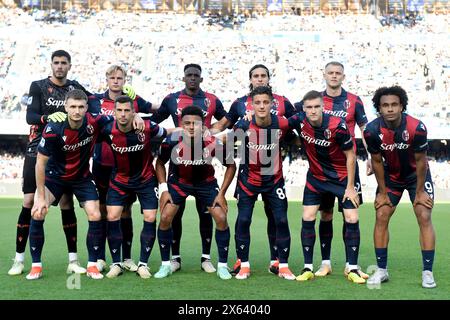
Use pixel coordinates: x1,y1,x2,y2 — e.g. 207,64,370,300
155,105,236,280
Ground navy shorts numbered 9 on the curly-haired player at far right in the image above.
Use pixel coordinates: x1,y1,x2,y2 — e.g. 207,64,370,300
376,169,434,206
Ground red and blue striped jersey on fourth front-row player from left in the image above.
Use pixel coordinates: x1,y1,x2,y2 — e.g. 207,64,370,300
234,114,289,186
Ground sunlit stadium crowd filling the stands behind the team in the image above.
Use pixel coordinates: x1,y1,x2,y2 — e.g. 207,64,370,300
0,9,450,127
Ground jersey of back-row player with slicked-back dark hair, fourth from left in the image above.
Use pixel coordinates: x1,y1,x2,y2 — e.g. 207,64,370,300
226,94,295,126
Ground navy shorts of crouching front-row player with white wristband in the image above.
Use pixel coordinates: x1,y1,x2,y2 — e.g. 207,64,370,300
167,176,219,207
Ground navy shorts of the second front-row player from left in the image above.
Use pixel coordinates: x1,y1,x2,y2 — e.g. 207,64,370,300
106,177,158,210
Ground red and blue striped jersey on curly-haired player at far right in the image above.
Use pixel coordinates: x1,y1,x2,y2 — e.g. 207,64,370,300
364,113,428,183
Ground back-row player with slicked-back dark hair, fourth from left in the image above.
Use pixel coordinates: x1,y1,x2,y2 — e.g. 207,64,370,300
212,64,295,274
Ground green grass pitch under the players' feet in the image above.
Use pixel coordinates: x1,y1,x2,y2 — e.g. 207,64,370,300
0,198,450,300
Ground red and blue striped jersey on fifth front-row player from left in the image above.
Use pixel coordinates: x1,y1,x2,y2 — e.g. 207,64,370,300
289,112,353,181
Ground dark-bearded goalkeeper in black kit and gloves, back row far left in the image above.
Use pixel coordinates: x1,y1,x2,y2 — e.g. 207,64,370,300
8,50,90,275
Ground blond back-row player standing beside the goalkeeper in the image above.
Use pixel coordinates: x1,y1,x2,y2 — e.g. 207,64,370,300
92,65,157,272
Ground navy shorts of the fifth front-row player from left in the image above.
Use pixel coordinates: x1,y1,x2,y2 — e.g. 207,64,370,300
303,172,362,211
